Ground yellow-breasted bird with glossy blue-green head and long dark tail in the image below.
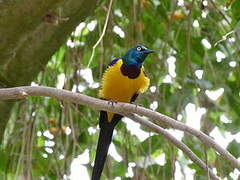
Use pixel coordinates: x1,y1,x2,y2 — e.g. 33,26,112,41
91,45,154,180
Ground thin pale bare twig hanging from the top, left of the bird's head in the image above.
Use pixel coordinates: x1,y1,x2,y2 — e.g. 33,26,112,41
87,0,113,68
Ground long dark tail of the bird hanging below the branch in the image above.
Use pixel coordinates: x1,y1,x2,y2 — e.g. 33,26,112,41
92,111,122,180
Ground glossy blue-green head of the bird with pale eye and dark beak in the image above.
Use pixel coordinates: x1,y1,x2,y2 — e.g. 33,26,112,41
122,46,154,68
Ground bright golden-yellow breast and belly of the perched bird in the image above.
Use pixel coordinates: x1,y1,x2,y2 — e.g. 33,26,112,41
99,60,150,121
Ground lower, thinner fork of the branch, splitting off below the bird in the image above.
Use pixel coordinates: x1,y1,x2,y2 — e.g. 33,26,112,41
126,114,219,180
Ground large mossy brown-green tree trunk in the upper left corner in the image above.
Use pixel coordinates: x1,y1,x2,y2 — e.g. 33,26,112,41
0,0,98,142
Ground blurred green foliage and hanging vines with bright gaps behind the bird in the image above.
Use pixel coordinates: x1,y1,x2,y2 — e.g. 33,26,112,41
0,0,240,180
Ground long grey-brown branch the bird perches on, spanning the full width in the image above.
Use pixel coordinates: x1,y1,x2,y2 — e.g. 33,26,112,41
0,86,240,170
